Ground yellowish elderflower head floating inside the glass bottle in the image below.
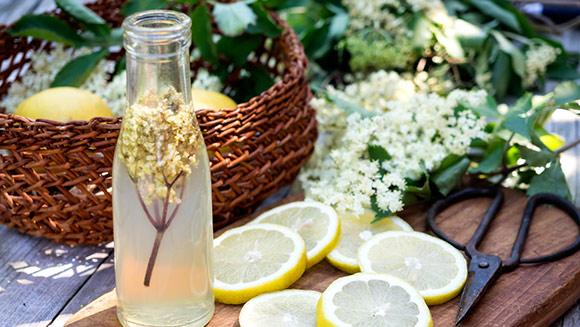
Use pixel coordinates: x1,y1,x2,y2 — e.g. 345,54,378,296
117,88,202,205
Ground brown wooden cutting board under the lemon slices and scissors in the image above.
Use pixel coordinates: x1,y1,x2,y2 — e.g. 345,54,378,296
66,190,580,327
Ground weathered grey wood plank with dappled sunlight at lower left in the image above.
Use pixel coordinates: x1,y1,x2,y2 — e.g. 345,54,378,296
0,226,110,327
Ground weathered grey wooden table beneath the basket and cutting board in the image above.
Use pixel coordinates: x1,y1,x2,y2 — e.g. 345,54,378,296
0,0,580,327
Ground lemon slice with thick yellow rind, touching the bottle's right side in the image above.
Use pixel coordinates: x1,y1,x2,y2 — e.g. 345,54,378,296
213,224,306,304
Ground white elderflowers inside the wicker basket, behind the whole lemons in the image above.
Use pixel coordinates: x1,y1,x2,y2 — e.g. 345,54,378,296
0,45,223,116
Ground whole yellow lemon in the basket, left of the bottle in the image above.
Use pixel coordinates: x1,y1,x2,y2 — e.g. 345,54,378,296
15,87,113,122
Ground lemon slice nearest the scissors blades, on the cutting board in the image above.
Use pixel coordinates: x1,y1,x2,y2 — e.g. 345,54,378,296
358,232,467,305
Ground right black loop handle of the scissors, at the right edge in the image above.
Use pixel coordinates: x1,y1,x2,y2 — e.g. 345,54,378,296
504,193,580,270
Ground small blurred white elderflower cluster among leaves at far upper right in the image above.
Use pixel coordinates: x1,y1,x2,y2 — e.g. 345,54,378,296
523,42,560,87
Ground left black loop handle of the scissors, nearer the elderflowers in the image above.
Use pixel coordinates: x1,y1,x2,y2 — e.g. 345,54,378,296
427,187,503,256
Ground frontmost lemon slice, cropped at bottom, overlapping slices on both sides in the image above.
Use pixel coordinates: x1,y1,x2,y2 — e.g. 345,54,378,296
316,273,433,327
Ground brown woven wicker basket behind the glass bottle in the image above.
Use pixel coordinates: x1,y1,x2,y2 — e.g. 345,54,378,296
0,0,317,244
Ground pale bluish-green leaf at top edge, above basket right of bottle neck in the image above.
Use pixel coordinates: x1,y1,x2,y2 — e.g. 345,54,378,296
213,1,258,36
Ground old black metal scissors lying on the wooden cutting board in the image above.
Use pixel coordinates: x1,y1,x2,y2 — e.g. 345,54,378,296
427,187,580,325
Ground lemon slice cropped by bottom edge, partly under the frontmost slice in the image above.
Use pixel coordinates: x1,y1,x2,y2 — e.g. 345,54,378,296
239,290,321,327
